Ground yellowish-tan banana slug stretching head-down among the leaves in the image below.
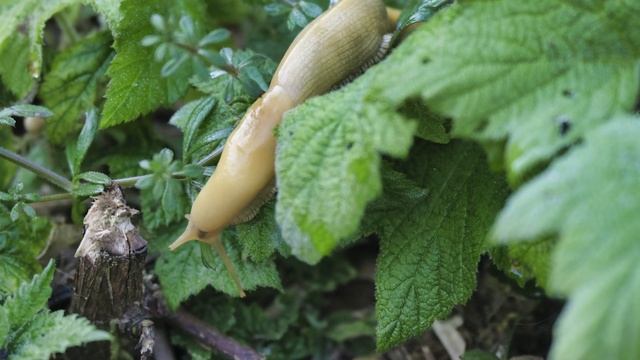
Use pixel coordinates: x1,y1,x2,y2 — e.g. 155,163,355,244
169,0,393,296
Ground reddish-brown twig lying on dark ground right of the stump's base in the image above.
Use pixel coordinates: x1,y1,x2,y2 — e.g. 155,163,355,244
166,310,264,360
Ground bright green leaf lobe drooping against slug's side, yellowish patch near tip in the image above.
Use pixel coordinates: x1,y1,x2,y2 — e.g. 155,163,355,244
276,63,416,263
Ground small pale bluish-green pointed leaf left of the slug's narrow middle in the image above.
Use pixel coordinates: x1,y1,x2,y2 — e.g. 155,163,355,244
169,97,216,161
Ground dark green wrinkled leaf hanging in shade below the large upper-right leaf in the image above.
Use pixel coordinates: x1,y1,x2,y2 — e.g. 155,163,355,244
365,141,506,350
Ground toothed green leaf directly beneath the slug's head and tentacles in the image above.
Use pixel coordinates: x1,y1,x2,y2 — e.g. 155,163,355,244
155,222,282,308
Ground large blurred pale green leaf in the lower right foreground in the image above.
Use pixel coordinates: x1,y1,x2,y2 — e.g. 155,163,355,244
494,116,640,360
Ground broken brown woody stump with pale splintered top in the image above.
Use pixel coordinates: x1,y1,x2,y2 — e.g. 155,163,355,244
69,186,147,360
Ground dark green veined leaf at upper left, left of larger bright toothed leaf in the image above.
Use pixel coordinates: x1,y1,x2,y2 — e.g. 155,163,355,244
40,32,113,143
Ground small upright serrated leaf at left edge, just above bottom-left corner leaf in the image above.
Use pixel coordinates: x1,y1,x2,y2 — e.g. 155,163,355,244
2,260,55,331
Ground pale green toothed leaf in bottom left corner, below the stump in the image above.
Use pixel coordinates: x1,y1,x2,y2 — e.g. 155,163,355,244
9,311,111,360
